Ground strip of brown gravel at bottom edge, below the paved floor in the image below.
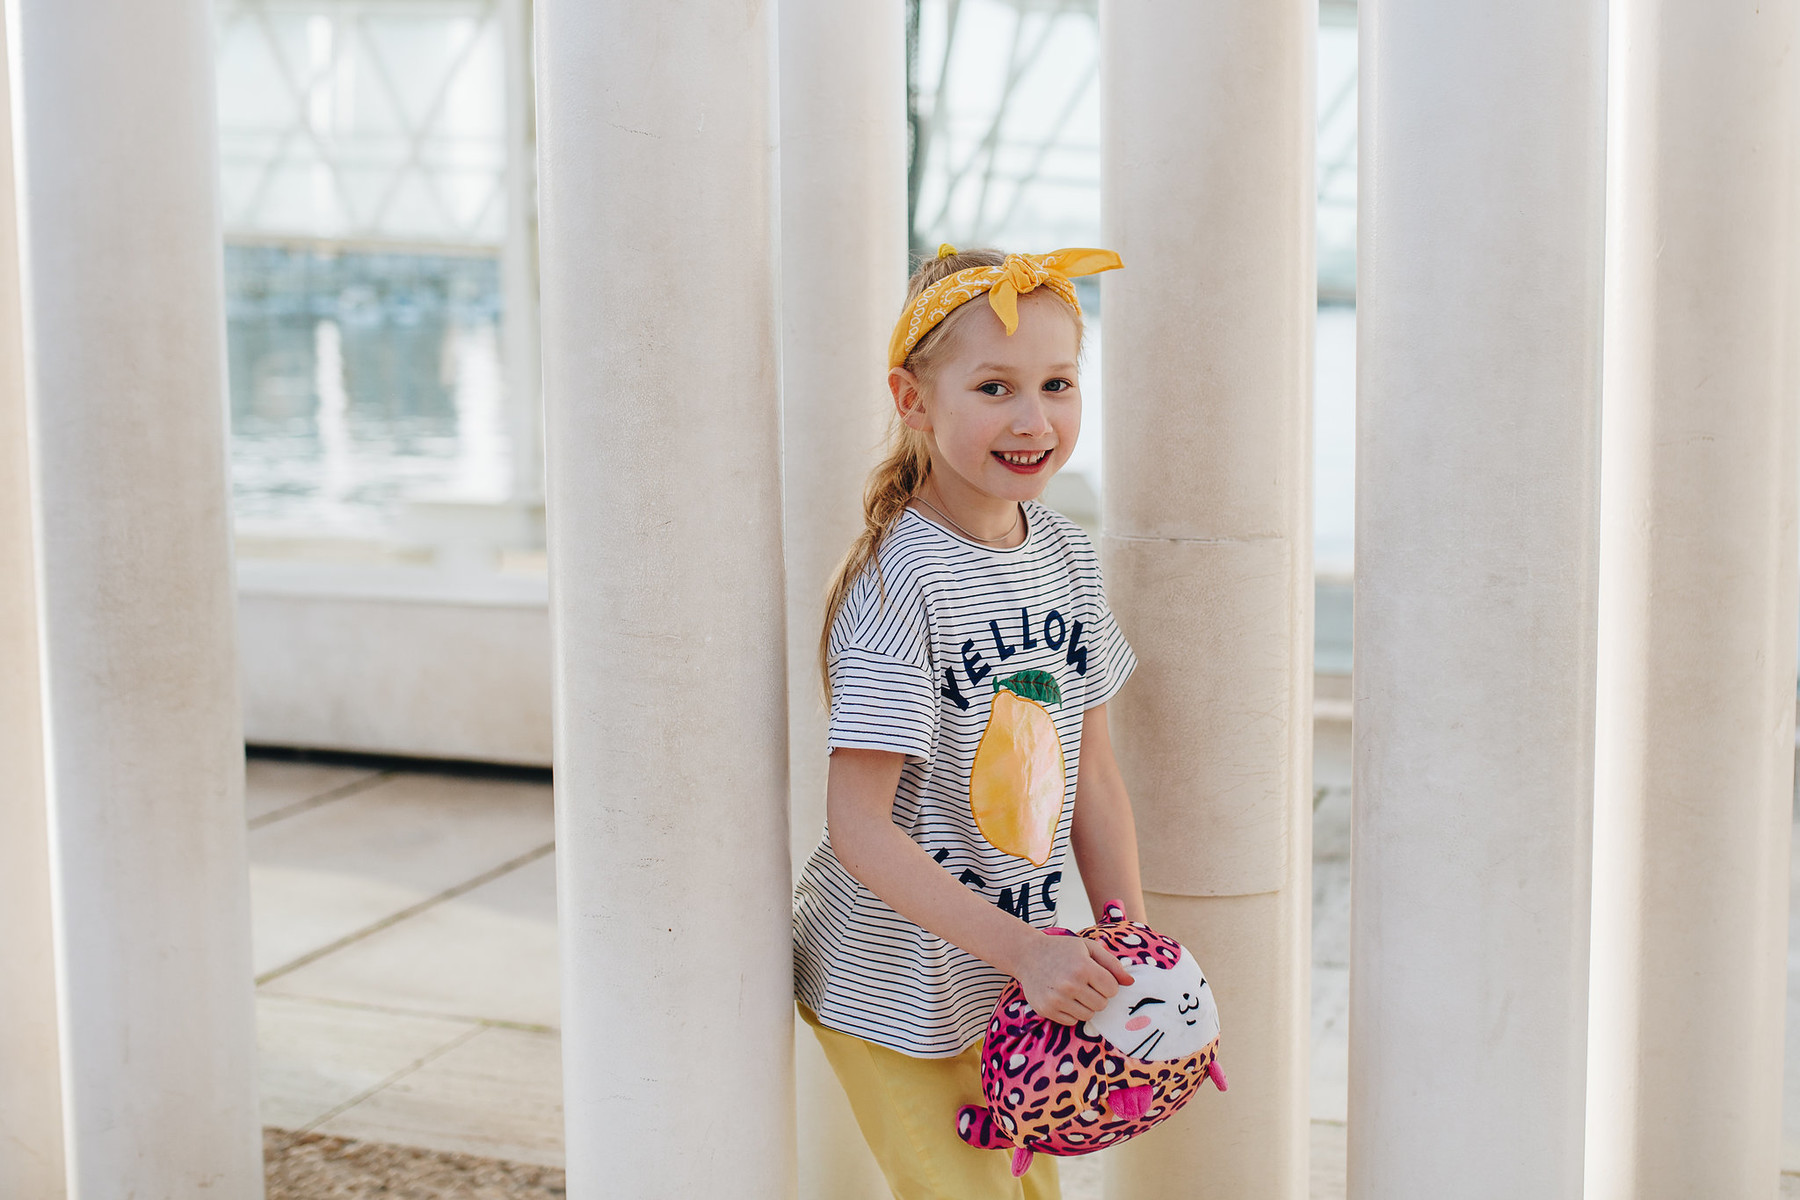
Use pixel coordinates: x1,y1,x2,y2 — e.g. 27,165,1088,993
263,1128,567,1200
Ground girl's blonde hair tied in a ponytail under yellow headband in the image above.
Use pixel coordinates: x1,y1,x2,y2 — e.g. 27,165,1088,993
819,250,1082,703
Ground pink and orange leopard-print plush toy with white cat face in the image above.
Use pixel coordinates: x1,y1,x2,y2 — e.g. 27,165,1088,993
956,900,1226,1177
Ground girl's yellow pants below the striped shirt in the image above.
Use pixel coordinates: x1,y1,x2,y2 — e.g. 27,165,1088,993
799,1004,1062,1200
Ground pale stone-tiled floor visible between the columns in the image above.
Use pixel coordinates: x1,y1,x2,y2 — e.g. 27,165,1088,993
248,741,1800,1200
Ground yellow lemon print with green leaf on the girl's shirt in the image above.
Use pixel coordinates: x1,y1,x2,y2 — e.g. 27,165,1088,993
968,671,1067,867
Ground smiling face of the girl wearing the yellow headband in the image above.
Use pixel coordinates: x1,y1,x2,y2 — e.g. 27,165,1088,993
887,291,1082,507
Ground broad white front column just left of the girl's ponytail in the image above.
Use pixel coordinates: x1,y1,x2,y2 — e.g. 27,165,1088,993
536,0,794,1200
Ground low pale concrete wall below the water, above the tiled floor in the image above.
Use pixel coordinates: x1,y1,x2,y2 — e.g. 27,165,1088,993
238,560,553,766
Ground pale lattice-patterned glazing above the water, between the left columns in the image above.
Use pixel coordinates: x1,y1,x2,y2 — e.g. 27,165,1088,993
216,0,506,248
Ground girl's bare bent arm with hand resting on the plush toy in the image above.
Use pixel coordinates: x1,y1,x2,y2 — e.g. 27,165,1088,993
824,748,1130,1025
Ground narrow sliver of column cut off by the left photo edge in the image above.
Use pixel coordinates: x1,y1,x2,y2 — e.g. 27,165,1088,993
0,7,65,1200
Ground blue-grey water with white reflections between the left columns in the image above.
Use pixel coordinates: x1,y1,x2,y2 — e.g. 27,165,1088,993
225,245,511,536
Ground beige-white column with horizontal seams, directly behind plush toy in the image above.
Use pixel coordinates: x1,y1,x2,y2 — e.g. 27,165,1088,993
1102,0,1318,1200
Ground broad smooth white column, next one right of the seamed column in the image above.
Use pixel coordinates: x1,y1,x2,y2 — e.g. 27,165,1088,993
1348,0,1605,1200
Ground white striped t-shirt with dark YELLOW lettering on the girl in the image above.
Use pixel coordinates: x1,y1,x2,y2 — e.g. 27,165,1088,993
794,504,1136,1058
